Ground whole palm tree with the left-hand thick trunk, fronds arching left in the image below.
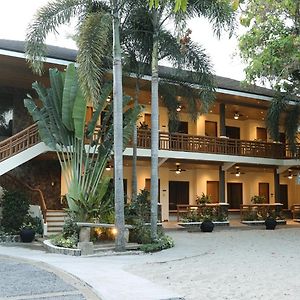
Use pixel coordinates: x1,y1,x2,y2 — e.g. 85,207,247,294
26,0,125,251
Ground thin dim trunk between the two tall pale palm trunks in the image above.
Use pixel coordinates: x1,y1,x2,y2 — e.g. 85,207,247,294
131,78,140,201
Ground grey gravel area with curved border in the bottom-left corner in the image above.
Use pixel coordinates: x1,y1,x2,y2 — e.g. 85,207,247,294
0,256,99,300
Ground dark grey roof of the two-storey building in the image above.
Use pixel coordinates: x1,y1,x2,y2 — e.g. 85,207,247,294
0,39,274,96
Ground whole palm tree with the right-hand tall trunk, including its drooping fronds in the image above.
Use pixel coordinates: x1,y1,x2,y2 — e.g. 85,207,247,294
122,0,236,239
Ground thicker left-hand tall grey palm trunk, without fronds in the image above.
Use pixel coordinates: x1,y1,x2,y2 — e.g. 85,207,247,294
112,0,125,251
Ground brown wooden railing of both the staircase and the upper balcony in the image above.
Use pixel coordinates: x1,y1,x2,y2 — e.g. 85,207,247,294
0,124,300,161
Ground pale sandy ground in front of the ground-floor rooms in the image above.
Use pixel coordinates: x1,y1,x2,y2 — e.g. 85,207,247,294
124,226,300,300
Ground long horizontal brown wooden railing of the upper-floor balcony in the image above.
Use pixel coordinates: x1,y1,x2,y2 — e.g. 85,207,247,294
138,130,300,159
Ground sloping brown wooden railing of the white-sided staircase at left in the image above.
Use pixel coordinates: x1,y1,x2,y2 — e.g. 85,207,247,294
0,124,41,161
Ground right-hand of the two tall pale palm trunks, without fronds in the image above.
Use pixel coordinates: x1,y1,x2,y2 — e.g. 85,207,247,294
150,9,159,240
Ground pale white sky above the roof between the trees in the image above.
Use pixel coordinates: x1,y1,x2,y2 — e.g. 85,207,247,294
0,0,245,80
